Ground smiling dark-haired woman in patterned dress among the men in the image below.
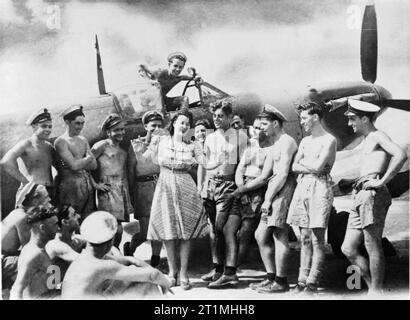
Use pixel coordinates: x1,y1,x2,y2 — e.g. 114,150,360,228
147,109,223,290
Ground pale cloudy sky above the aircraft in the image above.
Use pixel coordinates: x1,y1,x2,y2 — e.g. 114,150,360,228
0,0,410,115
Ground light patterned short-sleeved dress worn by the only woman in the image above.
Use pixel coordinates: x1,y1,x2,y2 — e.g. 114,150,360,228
147,136,208,240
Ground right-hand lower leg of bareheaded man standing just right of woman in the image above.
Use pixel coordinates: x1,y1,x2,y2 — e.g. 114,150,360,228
223,215,241,267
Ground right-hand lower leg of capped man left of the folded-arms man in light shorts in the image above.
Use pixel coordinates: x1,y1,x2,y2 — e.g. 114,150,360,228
272,227,290,277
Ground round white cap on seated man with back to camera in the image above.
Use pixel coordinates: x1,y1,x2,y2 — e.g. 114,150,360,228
80,211,118,244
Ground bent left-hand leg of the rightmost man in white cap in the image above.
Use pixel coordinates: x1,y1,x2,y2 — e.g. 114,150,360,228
342,229,370,288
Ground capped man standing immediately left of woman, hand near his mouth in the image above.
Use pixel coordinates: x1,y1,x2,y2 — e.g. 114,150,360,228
124,111,164,267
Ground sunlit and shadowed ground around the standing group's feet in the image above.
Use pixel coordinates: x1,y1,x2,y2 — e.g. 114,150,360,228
131,198,410,300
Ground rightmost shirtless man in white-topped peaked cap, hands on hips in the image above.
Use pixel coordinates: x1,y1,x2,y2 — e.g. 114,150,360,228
342,100,406,294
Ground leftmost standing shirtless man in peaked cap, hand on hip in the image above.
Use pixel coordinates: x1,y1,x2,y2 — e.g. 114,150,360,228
0,109,53,202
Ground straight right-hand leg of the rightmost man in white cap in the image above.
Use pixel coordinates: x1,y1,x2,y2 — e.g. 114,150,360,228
363,225,386,292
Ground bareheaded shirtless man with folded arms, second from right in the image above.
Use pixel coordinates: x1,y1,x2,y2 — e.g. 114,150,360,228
288,102,337,294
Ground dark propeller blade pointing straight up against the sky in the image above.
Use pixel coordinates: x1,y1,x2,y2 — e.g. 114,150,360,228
360,5,377,83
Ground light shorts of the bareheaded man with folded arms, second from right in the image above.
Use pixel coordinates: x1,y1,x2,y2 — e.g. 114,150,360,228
288,174,333,229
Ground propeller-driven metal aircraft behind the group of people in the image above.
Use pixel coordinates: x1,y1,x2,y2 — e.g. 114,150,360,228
0,5,410,217
